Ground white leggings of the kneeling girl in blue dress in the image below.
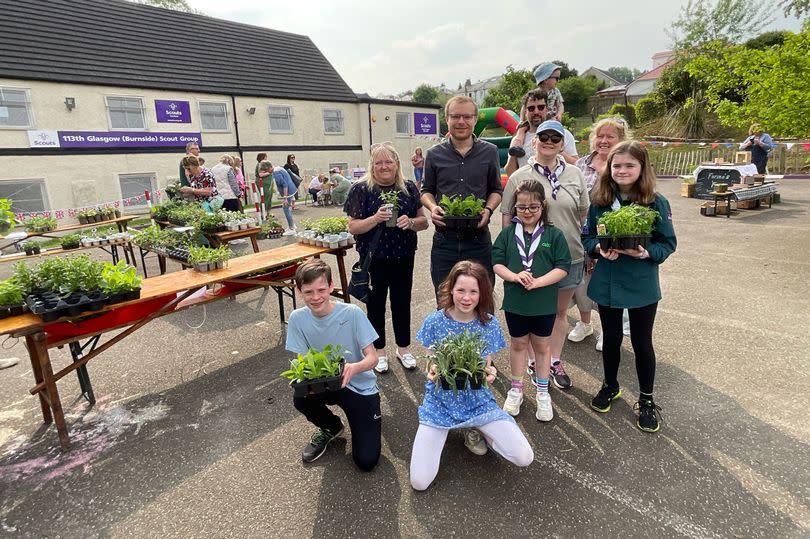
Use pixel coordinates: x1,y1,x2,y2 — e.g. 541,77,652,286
411,420,534,490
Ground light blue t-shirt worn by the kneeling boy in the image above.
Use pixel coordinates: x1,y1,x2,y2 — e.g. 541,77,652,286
285,303,378,395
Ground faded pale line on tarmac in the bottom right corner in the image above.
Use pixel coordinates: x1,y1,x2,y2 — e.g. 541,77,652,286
709,449,810,530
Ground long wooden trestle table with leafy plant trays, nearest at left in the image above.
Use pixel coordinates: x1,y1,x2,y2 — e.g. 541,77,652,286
0,243,350,450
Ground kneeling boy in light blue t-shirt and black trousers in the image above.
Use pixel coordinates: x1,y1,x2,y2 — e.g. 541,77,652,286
285,258,382,471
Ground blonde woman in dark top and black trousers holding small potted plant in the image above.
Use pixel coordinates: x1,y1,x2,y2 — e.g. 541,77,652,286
343,142,428,373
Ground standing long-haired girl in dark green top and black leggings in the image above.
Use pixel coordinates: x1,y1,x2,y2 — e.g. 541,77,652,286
584,141,677,432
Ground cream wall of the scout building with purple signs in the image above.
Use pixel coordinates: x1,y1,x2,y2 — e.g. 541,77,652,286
0,78,439,218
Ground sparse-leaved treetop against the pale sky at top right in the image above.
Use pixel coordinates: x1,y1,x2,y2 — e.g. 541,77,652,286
665,0,773,50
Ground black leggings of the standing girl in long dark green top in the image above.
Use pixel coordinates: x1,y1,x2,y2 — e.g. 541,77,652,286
599,302,658,395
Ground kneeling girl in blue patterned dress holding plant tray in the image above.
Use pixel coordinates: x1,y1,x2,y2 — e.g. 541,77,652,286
410,260,534,490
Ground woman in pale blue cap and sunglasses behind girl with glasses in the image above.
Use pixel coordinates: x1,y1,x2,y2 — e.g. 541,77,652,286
501,120,590,400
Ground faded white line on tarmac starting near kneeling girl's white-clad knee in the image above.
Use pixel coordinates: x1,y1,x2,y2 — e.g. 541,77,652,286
535,454,720,539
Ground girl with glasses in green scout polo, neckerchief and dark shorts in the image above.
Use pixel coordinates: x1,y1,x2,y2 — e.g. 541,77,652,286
492,179,571,421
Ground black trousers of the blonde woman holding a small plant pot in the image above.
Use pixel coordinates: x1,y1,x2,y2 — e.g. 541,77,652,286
367,256,414,350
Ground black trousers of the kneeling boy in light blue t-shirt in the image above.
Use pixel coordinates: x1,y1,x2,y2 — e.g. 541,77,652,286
293,388,382,472
